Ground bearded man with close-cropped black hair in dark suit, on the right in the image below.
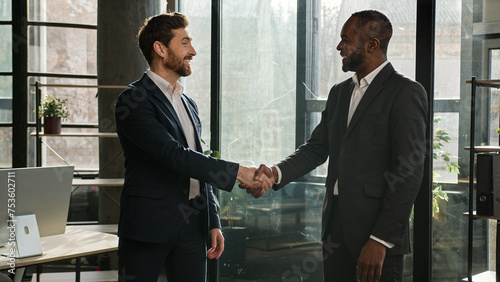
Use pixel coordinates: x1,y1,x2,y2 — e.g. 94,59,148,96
252,10,428,282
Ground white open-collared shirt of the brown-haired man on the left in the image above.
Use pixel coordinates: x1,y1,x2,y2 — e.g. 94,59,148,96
146,69,200,199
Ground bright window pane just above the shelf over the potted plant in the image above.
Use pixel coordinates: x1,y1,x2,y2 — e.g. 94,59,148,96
28,26,97,75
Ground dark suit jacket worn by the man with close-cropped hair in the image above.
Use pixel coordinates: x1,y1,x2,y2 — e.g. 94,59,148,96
275,64,428,258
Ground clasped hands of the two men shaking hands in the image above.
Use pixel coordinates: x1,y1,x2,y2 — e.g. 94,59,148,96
236,164,278,198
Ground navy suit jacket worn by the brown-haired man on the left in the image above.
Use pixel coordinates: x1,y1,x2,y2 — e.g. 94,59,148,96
115,74,239,243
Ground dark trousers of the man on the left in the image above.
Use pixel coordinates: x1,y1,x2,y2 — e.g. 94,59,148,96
118,199,206,282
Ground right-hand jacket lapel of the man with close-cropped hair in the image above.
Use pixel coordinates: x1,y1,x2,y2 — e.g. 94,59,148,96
345,63,394,139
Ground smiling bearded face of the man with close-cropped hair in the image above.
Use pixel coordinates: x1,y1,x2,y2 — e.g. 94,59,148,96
337,17,367,73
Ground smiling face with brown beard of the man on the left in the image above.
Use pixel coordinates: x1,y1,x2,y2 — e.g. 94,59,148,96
163,28,196,76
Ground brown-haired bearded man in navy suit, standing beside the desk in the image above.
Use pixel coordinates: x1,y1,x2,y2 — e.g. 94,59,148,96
116,13,272,282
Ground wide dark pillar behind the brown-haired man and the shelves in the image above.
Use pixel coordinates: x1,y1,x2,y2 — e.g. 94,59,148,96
97,0,160,223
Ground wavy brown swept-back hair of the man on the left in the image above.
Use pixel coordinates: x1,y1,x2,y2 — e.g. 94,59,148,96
137,13,189,64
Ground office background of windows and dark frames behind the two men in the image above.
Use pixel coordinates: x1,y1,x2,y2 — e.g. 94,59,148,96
0,0,500,281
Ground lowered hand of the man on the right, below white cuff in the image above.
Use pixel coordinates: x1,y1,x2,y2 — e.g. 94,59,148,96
356,239,386,282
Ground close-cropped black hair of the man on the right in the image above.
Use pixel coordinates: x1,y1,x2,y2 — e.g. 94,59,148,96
352,10,392,54
